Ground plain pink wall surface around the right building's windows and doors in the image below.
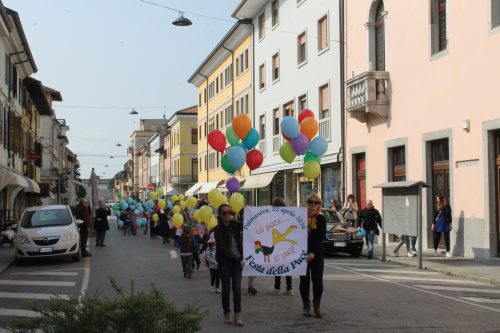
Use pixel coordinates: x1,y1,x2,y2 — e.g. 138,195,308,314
345,0,500,256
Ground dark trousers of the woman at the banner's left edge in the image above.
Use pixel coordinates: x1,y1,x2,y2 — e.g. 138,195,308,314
219,260,242,314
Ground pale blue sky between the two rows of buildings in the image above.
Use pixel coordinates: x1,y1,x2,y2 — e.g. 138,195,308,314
3,0,239,178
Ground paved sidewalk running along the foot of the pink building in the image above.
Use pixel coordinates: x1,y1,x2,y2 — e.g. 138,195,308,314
368,243,500,286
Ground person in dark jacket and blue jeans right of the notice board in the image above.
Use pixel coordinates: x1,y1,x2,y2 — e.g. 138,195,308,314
432,195,453,258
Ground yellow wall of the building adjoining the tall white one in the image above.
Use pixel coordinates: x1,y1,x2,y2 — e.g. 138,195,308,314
197,36,253,182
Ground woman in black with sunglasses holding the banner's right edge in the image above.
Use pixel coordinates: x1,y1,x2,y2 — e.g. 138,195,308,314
299,193,326,318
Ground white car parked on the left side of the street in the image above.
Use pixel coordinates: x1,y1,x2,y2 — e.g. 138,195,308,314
14,205,83,261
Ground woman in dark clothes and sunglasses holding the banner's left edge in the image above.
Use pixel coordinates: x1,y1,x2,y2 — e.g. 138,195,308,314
214,204,245,326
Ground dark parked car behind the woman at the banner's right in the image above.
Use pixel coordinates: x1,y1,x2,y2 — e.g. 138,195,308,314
321,208,364,257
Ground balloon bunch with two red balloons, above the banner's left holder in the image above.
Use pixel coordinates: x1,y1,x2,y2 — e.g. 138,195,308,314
208,114,264,192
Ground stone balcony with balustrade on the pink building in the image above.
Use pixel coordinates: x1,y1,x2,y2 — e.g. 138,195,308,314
346,71,389,122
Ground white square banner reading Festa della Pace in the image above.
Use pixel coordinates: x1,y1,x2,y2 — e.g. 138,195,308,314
243,206,307,276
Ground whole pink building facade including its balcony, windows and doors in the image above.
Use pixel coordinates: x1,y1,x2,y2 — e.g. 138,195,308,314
346,0,500,258
